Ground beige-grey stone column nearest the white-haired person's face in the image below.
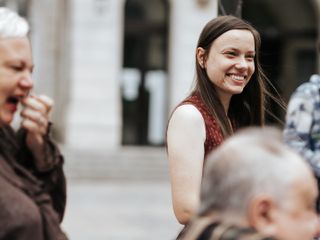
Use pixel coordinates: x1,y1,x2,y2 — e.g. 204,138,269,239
28,0,69,141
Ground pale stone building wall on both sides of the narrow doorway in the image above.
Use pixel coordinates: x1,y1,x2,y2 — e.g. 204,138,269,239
29,0,217,150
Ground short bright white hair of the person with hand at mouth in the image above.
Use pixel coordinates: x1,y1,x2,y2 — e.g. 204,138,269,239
0,7,29,38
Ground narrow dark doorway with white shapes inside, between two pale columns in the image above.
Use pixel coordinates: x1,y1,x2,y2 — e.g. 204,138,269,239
121,0,169,145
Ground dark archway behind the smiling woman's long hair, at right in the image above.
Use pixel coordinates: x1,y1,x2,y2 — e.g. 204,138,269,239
242,0,317,122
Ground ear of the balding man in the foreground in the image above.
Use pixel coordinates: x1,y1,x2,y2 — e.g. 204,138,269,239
248,195,277,236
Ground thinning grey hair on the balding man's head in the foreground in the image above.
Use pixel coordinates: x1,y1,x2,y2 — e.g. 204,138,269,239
199,128,311,217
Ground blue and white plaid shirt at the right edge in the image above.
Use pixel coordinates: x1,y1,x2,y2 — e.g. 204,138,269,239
284,75,320,178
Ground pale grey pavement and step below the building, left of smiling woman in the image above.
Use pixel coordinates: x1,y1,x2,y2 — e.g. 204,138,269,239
62,147,181,240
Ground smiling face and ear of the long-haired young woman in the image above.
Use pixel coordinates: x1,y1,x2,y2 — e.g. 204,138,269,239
197,29,255,101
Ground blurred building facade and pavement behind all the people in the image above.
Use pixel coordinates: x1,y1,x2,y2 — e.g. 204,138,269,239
0,0,320,240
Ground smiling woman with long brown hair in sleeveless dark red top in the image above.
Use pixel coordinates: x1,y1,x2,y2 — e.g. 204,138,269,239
167,16,284,238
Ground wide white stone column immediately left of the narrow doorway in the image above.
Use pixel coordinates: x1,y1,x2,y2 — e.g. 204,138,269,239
66,0,124,150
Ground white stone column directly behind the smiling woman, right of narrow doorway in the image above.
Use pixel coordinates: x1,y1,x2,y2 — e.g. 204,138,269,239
168,0,218,111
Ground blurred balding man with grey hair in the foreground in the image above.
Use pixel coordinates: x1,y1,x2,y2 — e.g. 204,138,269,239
182,128,319,240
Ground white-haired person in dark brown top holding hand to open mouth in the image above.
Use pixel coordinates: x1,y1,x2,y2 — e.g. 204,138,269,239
0,8,67,240
